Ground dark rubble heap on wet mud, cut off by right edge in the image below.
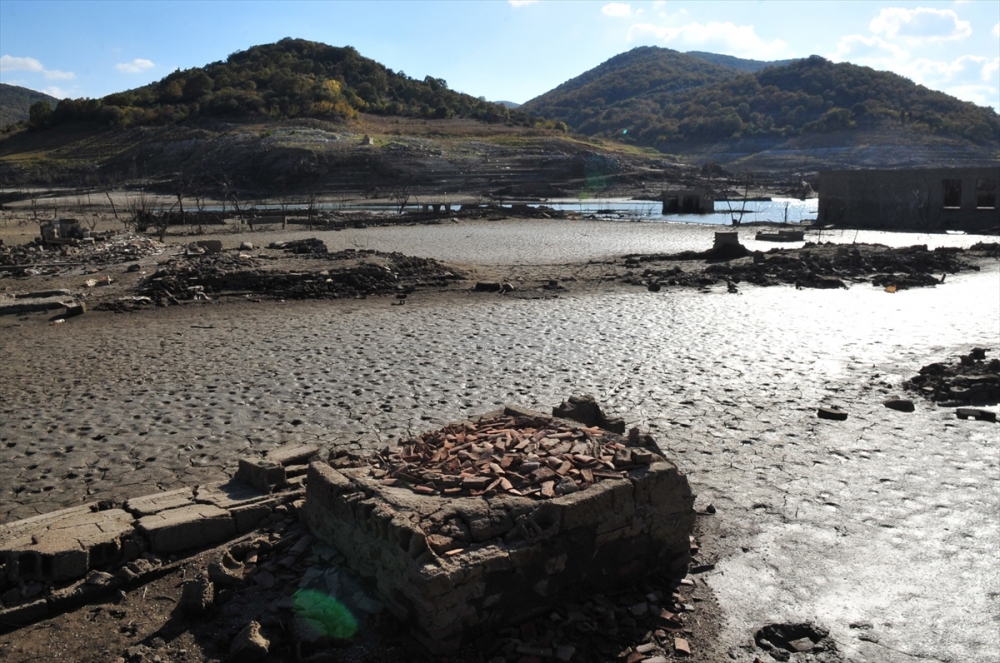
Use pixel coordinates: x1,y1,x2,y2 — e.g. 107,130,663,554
903,348,1000,405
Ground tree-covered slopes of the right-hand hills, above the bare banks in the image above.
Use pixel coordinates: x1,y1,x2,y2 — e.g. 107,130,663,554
523,49,1000,151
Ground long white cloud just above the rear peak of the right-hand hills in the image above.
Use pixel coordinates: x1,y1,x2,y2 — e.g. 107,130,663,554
628,21,785,59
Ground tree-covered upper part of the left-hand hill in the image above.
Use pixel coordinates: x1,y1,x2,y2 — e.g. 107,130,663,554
23,39,531,134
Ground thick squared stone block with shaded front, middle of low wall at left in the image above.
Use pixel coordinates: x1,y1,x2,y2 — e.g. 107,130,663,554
139,504,236,554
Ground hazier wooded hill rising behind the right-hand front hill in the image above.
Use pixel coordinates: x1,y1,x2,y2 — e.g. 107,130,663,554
520,46,741,133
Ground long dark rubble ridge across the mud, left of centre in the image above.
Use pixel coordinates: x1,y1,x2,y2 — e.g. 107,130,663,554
139,249,461,306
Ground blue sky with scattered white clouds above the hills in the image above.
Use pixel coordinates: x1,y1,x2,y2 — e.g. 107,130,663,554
0,0,1000,109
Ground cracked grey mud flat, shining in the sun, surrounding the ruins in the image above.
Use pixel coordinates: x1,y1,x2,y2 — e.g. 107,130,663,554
0,221,1000,663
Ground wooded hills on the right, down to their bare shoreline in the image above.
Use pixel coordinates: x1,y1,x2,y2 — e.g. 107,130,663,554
522,47,1000,166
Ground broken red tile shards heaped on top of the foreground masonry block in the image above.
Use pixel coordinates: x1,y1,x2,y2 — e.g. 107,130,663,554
371,416,656,499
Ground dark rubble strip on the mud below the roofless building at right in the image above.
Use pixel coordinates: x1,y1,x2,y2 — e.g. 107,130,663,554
624,242,990,290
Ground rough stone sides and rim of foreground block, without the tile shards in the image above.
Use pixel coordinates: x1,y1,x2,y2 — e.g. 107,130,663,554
302,410,694,652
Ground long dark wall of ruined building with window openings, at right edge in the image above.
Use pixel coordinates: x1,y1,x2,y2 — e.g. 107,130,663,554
817,167,1000,230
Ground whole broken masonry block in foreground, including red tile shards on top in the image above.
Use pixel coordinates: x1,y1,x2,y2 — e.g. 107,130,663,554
303,407,694,652
